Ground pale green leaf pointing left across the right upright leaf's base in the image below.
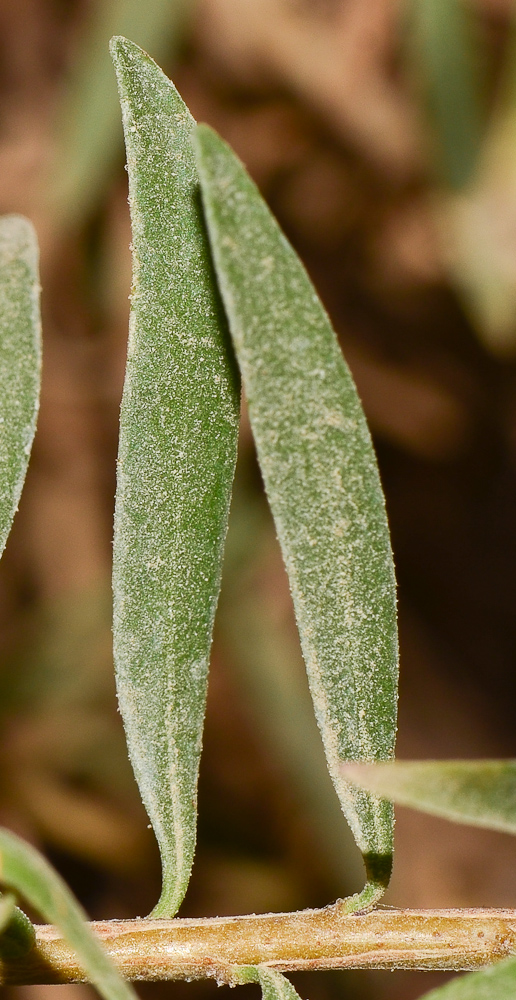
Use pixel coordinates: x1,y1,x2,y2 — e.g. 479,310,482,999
343,760,516,834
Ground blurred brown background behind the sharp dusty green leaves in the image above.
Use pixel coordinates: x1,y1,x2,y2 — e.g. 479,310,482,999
0,0,516,1000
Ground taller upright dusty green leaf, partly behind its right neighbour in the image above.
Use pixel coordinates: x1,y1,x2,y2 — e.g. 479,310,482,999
112,38,238,917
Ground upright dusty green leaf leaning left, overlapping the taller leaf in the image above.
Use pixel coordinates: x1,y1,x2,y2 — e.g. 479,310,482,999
196,126,397,905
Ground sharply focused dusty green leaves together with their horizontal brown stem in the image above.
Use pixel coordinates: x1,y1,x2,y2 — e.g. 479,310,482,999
0,31,516,1000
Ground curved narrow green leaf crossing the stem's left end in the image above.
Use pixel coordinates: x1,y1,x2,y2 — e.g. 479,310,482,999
0,829,137,1000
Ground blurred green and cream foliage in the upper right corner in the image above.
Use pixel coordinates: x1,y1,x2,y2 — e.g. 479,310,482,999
405,0,516,355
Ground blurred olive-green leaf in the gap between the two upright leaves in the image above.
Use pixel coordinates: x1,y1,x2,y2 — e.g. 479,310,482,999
217,465,362,895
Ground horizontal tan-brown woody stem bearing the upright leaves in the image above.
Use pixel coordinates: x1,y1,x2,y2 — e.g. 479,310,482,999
0,902,516,984
